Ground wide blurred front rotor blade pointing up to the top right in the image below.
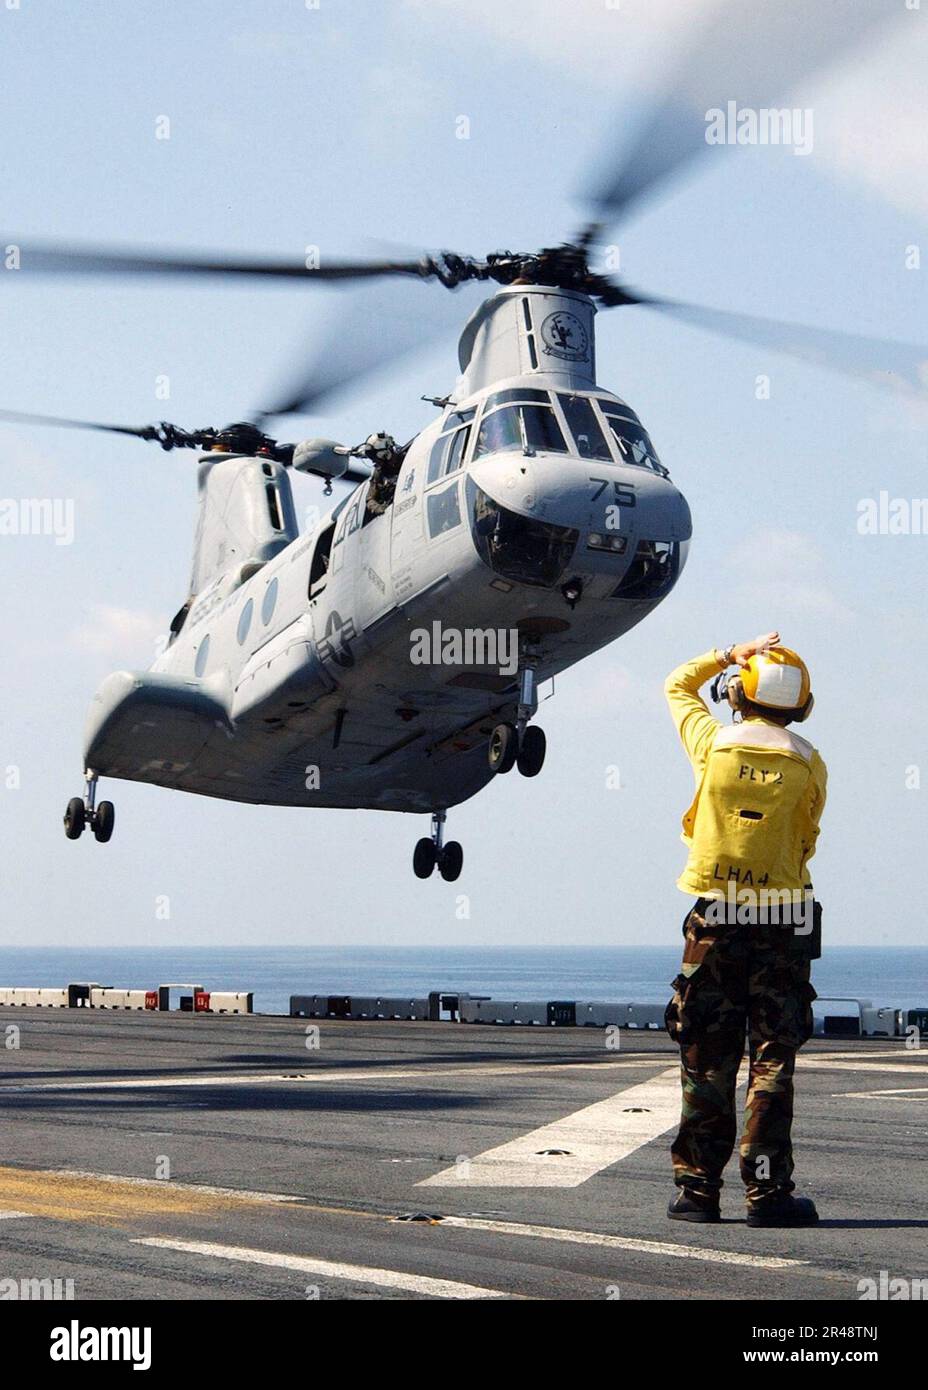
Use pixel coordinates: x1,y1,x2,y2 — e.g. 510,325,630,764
586,0,899,232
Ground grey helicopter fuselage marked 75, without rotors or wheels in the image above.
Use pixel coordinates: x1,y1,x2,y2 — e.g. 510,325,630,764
85,286,690,812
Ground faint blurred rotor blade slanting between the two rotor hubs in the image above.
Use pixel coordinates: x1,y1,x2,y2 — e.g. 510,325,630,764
253,273,486,424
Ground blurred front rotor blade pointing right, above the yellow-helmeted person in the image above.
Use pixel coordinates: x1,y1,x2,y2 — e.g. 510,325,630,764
639,296,928,395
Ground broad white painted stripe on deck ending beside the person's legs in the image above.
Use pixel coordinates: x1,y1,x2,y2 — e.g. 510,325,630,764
417,1066,681,1187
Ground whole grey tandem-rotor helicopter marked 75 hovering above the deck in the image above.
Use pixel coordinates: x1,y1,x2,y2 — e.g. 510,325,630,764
0,0,925,881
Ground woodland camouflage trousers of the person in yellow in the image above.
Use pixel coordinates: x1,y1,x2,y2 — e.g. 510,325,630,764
665,898,815,1201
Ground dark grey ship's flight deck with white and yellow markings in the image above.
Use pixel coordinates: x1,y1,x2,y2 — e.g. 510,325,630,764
0,1008,928,1300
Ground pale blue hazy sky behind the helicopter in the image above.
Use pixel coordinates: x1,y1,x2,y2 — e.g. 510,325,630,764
0,0,928,950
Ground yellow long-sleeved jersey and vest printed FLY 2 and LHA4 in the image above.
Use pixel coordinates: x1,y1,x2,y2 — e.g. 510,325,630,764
664,652,827,899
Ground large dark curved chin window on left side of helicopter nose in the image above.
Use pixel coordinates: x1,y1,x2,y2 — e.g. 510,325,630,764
467,478,579,588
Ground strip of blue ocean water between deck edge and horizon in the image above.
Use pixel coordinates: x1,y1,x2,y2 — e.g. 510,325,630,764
0,947,928,1013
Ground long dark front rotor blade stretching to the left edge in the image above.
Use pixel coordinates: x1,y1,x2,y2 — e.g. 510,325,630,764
2,238,429,281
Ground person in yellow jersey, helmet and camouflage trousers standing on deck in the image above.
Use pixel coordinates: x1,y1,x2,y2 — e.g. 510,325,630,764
664,632,827,1226
